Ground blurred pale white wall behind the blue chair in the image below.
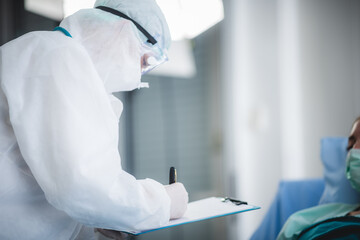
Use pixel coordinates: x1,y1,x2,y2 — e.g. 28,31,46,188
222,0,360,239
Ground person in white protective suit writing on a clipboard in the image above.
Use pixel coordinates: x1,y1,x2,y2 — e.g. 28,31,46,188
0,0,188,240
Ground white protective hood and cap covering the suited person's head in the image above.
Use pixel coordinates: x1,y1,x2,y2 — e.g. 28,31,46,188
60,0,171,93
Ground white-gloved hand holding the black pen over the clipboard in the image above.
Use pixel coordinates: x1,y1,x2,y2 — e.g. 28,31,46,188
165,182,189,219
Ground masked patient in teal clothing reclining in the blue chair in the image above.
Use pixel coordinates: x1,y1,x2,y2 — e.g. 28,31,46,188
277,117,360,240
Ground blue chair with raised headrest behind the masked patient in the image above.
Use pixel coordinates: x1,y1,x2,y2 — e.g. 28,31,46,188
251,137,360,240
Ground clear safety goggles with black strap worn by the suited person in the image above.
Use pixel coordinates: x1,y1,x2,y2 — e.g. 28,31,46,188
96,6,168,75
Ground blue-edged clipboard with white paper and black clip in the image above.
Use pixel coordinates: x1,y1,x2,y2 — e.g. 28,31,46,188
123,197,260,235
